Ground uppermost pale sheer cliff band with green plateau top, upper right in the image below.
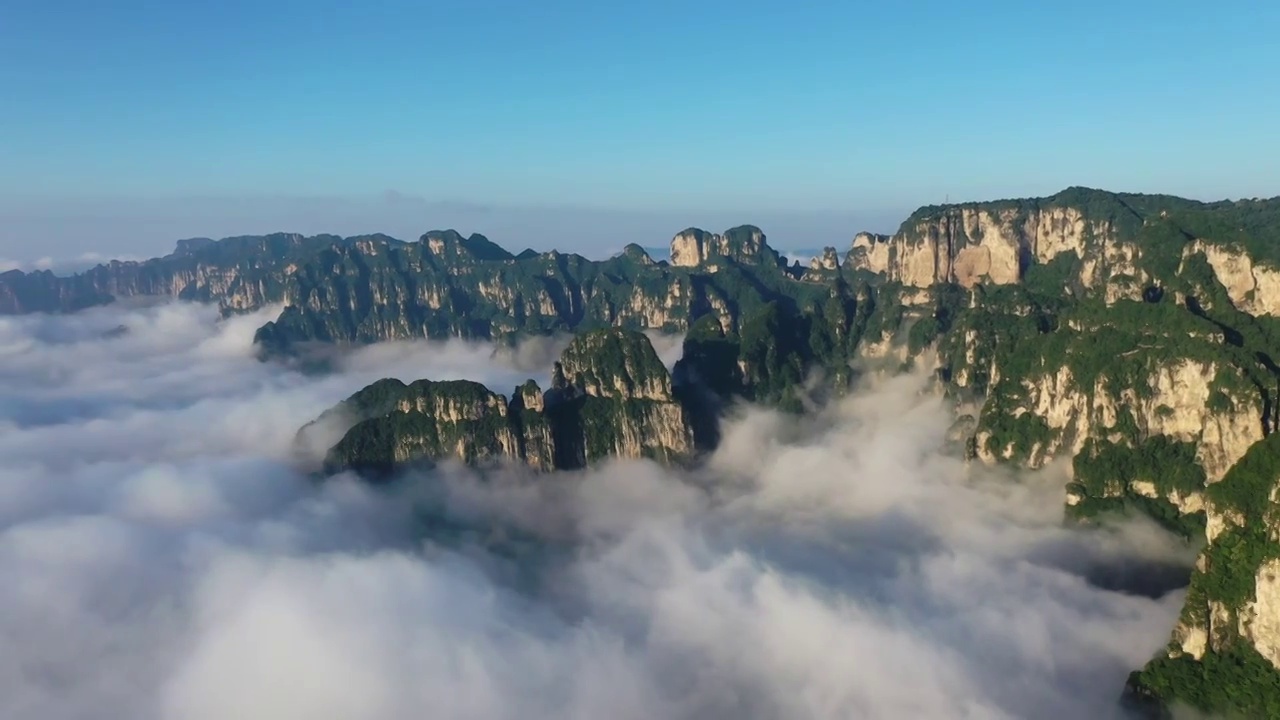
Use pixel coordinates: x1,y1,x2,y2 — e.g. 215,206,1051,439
845,187,1280,315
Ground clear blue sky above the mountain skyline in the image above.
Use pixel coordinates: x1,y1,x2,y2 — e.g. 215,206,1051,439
0,0,1280,260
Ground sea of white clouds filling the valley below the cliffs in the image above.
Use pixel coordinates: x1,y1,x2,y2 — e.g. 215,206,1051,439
0,304,1193,720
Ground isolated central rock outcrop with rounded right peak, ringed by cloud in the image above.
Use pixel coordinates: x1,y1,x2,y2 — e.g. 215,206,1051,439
314,329,694,475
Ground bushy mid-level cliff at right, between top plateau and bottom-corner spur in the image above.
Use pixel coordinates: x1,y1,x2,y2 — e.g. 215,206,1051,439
926,252,1280,536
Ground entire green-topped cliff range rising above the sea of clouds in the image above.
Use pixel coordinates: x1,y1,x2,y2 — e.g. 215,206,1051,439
0,188,1280,717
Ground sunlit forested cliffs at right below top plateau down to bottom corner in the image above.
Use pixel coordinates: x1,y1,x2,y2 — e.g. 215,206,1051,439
896,241,1280,717
